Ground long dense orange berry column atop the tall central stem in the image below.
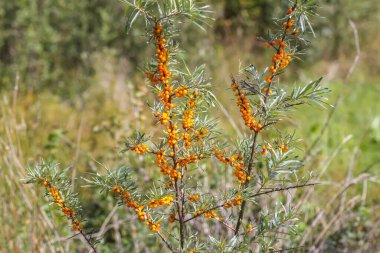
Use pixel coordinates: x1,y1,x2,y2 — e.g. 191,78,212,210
154,22,171,84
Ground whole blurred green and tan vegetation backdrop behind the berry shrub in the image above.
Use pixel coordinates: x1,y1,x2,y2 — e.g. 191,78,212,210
0,0,380,252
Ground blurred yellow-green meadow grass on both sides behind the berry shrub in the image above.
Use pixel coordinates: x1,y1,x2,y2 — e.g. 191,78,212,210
0,70,380,252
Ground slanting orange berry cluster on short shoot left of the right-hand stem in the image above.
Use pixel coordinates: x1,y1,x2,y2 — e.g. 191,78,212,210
231,83,262,132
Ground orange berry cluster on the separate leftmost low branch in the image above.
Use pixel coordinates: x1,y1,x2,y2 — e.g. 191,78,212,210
40,180,82,231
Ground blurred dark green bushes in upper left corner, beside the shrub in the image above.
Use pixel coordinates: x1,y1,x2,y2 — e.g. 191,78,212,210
0,0,144,95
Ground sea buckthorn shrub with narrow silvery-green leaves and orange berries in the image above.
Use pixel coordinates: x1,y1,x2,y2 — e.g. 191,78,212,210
28,0,328,253
